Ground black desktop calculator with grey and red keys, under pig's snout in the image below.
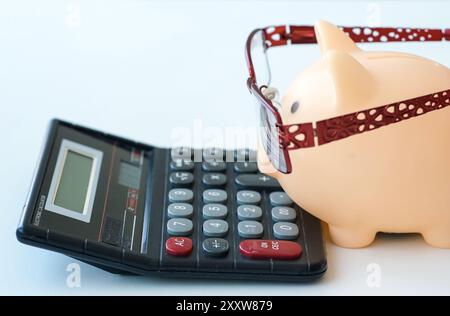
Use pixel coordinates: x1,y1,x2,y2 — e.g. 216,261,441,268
17,120,327,281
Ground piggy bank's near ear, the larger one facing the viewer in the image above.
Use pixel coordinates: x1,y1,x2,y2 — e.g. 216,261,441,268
325,51,374,106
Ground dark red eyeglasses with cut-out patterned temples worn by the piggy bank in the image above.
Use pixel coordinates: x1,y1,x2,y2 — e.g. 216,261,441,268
246,25,450,173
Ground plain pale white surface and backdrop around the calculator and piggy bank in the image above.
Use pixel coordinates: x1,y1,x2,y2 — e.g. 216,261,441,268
0,0,450,295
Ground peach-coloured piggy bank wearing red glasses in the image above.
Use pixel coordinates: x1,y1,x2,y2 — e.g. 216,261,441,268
258,21,450,248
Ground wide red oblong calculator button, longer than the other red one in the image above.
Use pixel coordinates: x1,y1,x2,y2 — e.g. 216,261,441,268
239,239,302,260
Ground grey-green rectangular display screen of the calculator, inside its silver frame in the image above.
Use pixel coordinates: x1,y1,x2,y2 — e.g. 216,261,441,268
54,150,94,213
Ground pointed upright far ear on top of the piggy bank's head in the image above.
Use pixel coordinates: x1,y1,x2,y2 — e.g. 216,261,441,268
314,21,359,55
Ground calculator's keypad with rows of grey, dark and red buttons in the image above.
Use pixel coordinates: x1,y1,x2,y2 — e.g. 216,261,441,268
162,148,303,271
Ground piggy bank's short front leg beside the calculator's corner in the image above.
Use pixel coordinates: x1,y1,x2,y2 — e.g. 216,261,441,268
329,225,376,248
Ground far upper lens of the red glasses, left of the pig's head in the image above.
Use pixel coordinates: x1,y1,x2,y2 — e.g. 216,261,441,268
250,30,271,86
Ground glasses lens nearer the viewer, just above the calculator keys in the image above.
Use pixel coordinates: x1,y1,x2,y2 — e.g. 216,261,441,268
259,104,288,173
